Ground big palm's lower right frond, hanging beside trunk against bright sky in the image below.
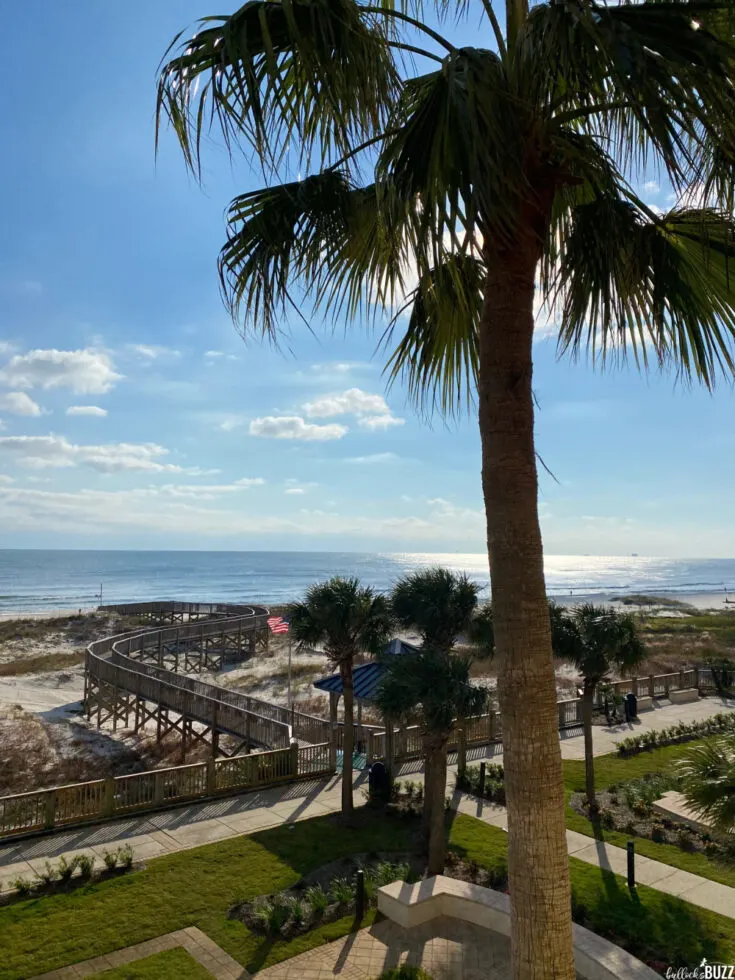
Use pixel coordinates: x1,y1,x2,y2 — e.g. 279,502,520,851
556,195,735,387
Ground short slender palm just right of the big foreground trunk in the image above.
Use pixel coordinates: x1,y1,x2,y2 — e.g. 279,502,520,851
551,603,646,812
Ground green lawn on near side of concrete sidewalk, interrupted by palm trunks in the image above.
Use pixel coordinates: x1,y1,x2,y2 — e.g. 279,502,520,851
0,808,735,980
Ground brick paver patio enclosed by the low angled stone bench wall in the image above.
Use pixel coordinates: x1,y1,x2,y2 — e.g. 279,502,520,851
258,916,510,980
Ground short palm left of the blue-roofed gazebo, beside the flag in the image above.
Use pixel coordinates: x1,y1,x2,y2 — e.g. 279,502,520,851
289,577,393,821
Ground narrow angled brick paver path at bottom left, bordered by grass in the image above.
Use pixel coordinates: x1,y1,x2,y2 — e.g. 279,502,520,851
34,927,250,980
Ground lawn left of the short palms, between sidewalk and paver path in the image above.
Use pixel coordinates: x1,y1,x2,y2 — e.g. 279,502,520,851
0,808,415,980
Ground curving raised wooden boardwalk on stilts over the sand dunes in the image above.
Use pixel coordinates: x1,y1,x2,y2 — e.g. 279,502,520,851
85,602,330,756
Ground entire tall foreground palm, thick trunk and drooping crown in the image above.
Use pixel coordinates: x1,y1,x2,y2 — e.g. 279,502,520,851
158,0,735,980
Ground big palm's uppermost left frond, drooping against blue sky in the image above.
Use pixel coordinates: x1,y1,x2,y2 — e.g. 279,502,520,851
156,0,397,173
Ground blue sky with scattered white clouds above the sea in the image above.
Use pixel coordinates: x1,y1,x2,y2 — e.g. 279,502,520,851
0,0,735,557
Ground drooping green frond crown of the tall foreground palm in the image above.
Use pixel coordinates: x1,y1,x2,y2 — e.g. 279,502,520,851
158,0,735,398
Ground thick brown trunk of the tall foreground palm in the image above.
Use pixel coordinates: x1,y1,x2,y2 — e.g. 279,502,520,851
478,237,575,980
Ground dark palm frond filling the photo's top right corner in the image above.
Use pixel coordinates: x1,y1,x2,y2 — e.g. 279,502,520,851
519,0,735,195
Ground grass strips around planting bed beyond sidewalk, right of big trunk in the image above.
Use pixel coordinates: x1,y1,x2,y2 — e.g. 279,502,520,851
563,740,735,888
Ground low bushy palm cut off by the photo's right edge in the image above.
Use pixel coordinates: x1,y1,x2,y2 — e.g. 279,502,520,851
676,735,735,834
